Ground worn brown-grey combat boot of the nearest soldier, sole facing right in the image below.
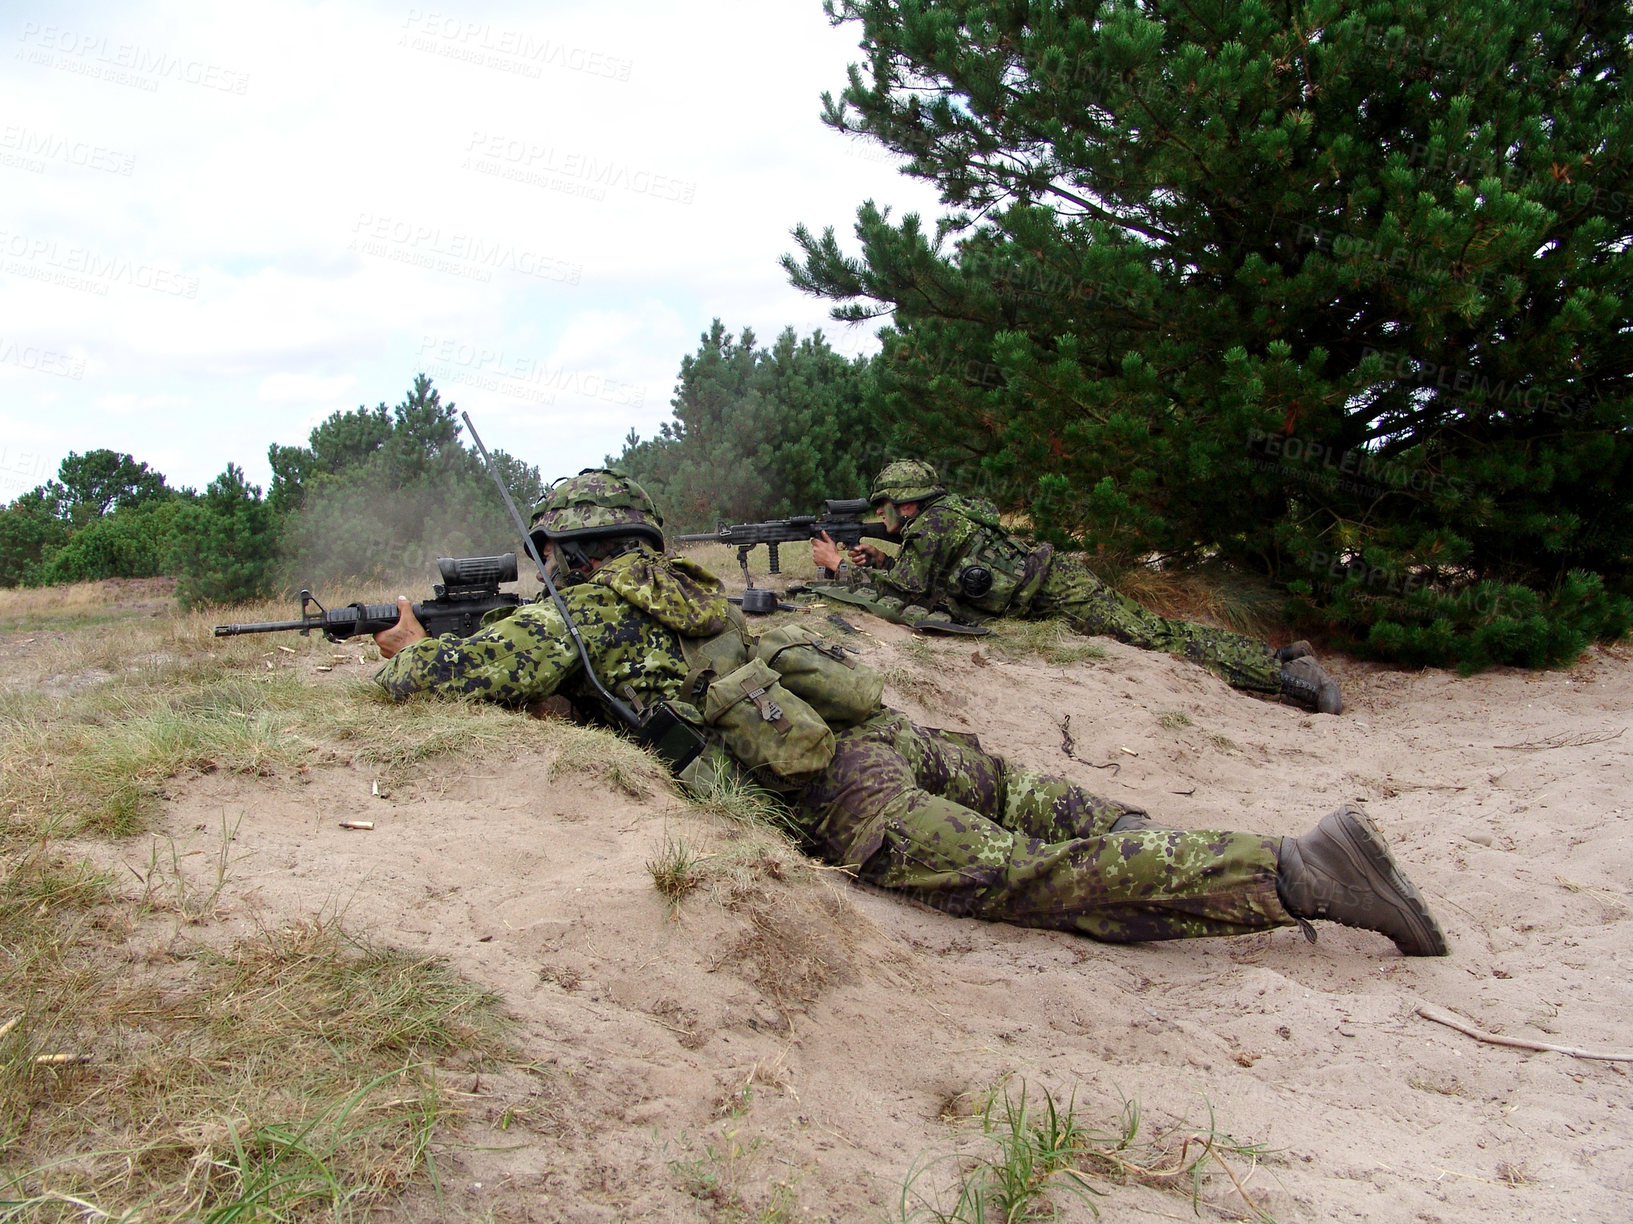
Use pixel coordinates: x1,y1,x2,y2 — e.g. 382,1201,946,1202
1275,803,1447,956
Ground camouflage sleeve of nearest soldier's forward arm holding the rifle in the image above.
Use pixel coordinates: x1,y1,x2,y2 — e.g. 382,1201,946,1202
374,602,581,705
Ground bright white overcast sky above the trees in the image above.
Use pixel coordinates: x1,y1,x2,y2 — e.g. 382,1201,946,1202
0,0,936,501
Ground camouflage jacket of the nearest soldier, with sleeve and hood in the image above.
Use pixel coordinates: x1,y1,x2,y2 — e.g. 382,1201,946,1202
374,545,730,723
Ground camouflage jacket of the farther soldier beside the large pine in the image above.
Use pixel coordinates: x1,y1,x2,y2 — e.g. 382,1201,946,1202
874,493,1055,619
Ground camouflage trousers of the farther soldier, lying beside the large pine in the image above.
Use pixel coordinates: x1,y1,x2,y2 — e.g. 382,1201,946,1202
1027,558,1282,694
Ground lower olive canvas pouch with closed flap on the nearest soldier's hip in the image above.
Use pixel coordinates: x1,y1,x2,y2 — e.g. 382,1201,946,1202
702,658,834,790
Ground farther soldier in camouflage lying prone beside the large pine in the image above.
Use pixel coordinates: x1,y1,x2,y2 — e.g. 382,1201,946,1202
812,459,1342,715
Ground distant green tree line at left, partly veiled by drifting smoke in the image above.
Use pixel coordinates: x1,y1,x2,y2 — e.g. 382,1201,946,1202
0,375,542,605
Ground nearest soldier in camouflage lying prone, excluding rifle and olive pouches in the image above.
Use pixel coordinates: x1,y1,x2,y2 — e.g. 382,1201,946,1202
376,470,1445,955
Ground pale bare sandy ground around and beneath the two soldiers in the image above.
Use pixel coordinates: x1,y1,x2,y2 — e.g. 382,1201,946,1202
79,615,1633,1222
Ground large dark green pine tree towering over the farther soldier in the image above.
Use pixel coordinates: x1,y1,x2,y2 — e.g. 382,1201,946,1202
785,0,1633,664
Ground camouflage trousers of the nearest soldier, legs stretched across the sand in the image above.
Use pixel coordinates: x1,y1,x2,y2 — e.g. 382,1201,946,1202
795,710,1293,943
